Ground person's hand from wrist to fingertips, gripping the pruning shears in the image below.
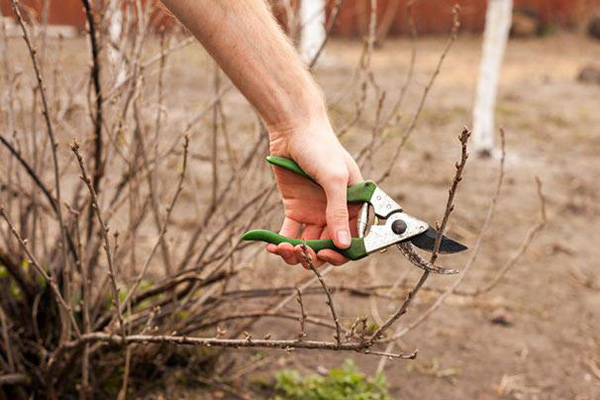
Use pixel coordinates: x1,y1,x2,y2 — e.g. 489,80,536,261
267,116,363,268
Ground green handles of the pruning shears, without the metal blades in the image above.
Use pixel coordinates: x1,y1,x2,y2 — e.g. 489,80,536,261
242,156,377,260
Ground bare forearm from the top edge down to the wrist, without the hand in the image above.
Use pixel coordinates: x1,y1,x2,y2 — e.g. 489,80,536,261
163,0,325,129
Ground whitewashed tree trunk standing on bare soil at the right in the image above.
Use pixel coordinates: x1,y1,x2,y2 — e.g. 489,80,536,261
473,0,513,155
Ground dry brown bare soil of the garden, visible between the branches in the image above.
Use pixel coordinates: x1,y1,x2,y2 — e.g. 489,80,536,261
5,29,600,400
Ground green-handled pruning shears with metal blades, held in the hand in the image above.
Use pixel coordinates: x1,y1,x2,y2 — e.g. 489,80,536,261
242,156,467,274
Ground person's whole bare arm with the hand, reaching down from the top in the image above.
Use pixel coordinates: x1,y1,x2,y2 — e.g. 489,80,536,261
163,0,362,267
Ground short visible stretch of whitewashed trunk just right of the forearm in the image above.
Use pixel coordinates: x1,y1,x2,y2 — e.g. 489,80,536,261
300,0,326,62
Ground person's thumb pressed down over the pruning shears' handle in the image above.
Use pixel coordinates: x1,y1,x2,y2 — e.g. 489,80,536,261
323,173,351,249
